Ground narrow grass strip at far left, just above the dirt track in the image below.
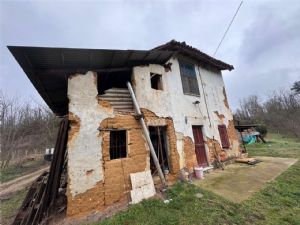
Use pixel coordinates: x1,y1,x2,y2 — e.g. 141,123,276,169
0,159,47,183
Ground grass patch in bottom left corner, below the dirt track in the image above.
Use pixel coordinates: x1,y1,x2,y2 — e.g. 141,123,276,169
0,189,28,224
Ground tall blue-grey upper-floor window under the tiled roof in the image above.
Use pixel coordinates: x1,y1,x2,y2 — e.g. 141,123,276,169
179,62,200,95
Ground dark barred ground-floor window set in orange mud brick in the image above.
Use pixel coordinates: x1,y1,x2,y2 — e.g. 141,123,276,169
109,130,127,159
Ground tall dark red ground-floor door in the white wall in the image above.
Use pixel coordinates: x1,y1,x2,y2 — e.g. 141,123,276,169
192,126,208,167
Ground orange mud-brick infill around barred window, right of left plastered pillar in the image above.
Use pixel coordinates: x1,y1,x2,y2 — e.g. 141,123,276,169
100,115,150,206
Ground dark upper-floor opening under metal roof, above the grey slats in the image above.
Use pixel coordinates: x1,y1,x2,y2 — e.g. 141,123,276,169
97,70,131,95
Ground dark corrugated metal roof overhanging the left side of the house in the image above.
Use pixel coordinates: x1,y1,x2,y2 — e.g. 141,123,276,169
8,46,174,115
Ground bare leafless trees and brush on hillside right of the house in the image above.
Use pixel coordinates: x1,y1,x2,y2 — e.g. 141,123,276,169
235,81,300,138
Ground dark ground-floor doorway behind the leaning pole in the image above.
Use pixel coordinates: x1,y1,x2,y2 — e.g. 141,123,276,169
149,126,170,175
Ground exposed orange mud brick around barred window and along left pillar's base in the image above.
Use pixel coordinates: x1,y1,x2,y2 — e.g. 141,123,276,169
67,115,150,217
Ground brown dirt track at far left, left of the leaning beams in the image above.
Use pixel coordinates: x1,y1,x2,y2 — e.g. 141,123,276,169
0,167,49,199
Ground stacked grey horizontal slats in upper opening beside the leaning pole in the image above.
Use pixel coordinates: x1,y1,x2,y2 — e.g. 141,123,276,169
99,88,133,112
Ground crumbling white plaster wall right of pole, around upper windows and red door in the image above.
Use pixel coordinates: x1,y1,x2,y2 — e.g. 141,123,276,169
133,58,239,168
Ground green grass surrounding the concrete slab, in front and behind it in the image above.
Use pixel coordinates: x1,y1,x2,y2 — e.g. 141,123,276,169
93,135,300,225
